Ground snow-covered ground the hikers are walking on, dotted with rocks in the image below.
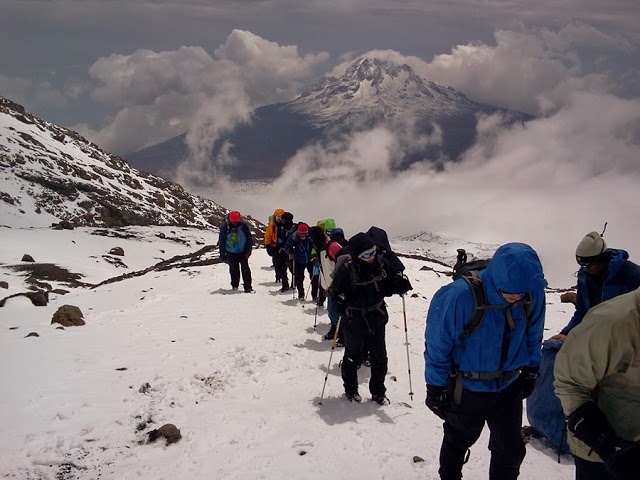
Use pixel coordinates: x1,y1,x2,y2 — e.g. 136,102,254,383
0,227,574,480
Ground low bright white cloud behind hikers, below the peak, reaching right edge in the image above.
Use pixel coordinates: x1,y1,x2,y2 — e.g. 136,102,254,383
206,92,640,287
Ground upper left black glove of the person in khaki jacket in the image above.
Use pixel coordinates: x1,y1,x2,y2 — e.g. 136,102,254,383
567,402,616,463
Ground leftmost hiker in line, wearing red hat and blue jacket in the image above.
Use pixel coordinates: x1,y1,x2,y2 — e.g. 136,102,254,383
218,210,253,293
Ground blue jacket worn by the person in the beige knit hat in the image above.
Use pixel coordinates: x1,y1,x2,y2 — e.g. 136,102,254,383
560,248,640,335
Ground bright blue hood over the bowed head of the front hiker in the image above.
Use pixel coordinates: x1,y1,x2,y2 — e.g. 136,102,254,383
484,243,547,295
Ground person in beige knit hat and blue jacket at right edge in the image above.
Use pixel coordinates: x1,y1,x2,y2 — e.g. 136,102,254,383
551,232,640,341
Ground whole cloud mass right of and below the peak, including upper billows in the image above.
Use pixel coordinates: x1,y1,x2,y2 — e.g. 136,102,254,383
196,29,640,287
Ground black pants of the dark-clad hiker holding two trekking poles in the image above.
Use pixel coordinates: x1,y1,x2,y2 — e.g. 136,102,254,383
340,306,389,395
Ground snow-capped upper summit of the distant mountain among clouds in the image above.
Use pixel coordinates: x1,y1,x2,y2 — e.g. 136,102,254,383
293,57,478,121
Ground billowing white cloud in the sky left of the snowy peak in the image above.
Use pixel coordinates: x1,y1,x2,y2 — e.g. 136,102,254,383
84,30,328,153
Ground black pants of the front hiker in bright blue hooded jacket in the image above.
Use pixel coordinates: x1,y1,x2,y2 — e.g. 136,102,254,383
438,380,526,480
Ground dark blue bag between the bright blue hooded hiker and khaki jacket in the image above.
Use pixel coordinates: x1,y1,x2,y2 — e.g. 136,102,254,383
527,339,570,454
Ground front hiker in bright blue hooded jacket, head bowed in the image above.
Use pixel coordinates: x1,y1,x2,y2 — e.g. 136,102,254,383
424,243,547,480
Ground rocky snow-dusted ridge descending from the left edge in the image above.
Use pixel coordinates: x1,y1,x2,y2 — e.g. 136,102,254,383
0,97,264,232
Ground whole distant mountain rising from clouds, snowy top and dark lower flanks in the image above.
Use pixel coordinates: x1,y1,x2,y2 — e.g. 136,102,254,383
125,58,533,180
